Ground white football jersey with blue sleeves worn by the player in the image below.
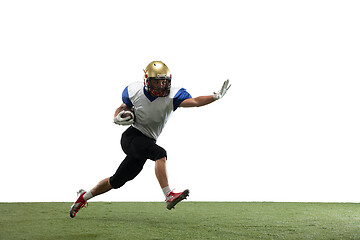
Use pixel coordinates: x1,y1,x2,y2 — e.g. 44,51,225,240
122,82,191,140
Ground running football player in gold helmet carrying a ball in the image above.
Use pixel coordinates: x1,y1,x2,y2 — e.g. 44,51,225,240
70,61,231,217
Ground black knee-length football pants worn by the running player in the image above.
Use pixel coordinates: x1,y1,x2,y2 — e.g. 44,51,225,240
110,127,166,188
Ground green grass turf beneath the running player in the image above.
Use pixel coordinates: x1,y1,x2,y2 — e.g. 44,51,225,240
0,202,360,240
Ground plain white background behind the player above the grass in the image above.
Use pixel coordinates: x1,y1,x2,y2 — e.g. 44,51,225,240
0,0,360,202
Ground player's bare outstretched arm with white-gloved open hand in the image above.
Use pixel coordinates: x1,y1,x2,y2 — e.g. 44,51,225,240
180,79,231,107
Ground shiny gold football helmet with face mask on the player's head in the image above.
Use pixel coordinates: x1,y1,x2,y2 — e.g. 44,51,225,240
144,61,172,97
